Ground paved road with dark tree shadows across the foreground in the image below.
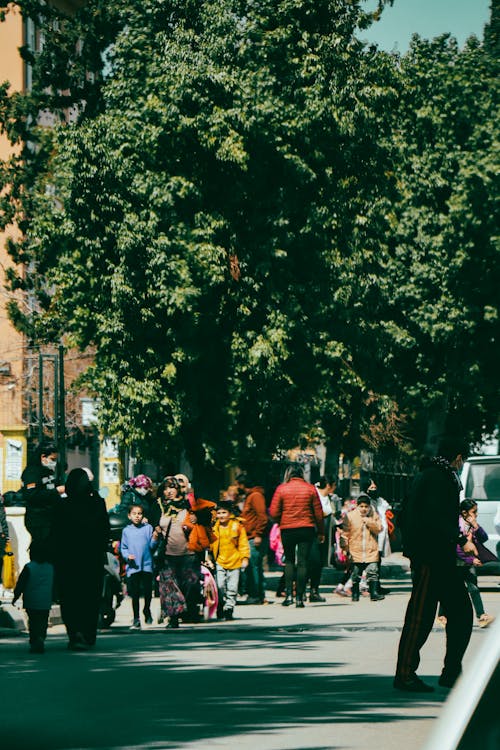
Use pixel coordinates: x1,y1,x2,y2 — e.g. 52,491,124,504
0,579,500,750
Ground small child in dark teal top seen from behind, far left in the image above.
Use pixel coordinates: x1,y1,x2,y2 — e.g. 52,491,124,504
12,540,54,654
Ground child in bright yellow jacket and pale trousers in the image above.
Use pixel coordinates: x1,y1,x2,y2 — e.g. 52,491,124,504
212,504,250,620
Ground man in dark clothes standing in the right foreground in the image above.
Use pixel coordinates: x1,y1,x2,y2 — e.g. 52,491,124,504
394,440,473,693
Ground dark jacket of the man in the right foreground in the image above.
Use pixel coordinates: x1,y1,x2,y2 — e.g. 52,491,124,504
401,463,466,565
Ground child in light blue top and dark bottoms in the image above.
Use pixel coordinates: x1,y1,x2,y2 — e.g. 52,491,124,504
120,505,158,630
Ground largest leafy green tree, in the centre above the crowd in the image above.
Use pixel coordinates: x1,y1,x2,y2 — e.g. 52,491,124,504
0,0,402,482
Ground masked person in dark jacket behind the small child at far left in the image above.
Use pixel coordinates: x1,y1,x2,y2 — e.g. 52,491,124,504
21,444,64,544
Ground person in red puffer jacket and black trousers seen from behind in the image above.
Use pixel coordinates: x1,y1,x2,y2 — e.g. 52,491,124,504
269,464,325,607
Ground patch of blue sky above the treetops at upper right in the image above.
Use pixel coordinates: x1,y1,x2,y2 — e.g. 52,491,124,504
360,0,491,52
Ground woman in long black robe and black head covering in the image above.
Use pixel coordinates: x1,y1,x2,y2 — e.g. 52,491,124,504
55,469,109,651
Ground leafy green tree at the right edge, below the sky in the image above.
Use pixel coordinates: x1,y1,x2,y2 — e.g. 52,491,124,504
368,30,500,447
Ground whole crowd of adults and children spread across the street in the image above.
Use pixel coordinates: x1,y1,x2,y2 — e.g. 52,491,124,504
0,438,493,692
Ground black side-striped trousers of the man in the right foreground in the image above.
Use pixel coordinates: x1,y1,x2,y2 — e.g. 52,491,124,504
396,560,472,680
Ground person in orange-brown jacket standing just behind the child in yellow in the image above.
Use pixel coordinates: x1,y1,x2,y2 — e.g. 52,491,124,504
236,474,269,604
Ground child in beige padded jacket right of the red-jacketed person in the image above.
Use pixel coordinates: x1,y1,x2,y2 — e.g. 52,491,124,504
342,494,385,602
